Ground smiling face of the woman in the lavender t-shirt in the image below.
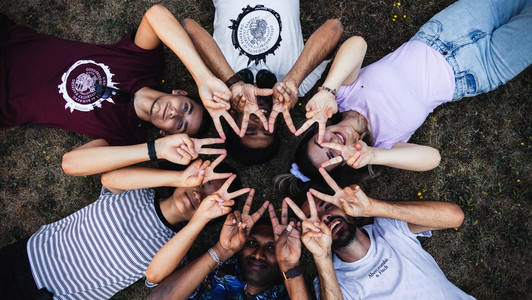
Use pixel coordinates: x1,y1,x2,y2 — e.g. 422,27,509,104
307,122,360,171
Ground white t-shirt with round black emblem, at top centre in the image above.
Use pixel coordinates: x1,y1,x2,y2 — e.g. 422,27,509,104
213,0,329,97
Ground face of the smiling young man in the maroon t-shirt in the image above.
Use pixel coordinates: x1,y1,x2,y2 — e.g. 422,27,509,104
150,94,203,136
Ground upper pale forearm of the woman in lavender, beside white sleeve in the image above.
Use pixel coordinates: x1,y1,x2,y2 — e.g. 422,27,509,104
323,36,367,90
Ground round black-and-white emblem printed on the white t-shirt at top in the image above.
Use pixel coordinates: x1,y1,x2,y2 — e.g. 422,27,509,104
229,5,283,65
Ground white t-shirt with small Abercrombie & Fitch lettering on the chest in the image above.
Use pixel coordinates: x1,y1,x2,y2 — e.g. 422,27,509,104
314,218,474,300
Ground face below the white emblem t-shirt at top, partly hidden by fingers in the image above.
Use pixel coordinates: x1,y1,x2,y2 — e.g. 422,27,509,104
236,97,273,149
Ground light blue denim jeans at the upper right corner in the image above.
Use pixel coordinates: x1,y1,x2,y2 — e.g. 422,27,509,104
412,0,532,100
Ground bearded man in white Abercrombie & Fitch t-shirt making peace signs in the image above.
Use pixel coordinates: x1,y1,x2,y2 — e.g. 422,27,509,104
286,168,474,299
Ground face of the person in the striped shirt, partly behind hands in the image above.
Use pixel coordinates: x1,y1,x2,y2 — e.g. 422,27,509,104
173,180,224,220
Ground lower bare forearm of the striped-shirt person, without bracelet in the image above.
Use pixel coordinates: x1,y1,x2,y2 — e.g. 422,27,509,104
146,217,212,283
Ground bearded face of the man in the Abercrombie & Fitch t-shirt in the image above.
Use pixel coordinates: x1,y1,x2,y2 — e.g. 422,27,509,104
301,198,357,250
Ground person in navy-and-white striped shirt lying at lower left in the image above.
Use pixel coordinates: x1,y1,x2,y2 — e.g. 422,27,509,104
0,156,249,299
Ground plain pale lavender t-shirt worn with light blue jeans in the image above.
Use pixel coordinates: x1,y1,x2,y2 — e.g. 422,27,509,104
336,41,455,149
